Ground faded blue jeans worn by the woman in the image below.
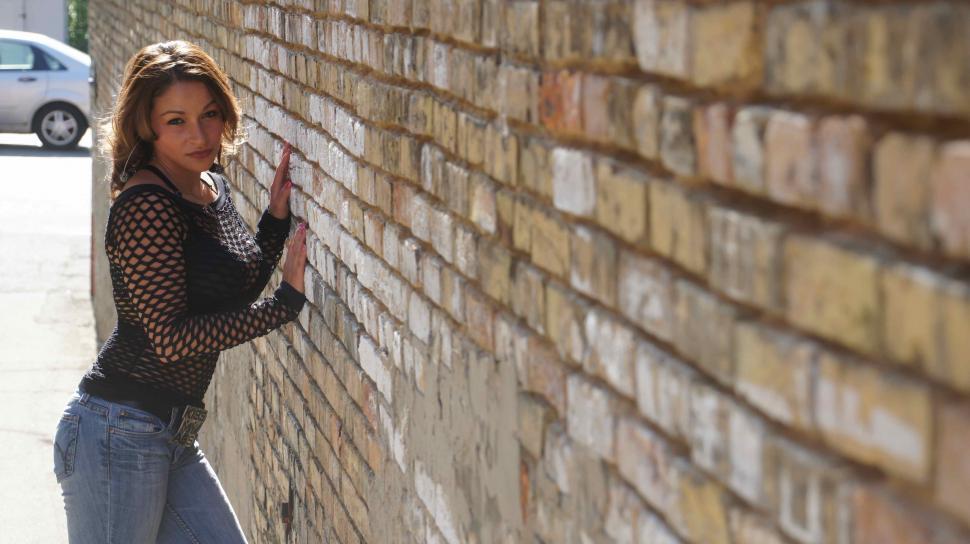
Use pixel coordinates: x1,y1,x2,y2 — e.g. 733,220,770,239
54,392,246,544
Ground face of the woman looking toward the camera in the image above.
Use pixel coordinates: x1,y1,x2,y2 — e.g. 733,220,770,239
151,81,225,173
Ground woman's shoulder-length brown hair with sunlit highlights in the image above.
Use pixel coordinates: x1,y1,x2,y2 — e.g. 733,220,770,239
101,40,242,199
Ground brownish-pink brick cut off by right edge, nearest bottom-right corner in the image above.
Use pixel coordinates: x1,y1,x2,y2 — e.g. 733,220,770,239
934,401,970,521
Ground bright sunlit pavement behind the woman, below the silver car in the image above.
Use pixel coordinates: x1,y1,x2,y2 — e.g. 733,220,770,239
0,131,97,544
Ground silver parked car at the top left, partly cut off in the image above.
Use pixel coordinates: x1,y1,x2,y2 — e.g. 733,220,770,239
0,30,94,149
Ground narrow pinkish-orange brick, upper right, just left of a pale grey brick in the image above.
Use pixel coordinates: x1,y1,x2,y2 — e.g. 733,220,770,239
694,102,734,185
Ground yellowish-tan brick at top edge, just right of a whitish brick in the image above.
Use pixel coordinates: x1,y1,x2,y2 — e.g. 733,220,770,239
690,1,762,88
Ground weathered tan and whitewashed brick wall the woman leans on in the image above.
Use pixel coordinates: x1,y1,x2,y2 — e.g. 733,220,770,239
91,0,970,544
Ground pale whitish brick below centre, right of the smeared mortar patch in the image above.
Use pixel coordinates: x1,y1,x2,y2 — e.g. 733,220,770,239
566,374,615,461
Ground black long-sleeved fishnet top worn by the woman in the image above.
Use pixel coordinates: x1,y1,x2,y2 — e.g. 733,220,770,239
82,169,306,406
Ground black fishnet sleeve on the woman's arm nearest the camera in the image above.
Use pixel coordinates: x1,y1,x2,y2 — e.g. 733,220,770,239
108,191,302,363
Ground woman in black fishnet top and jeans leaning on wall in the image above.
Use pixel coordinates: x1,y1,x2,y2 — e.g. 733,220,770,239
54,41,306,544
